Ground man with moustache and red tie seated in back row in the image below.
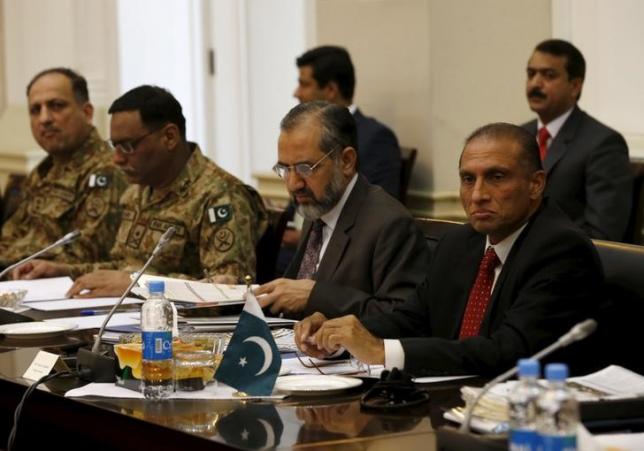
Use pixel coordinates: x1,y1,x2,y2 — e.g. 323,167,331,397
524,39,633,241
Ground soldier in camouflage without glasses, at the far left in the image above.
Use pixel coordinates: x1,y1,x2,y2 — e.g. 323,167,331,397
0,68,126,267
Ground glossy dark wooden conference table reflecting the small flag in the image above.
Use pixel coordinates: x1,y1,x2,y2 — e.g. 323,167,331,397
0,308,506,450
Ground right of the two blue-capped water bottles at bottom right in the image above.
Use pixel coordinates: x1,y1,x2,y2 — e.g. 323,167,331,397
537,363,579,451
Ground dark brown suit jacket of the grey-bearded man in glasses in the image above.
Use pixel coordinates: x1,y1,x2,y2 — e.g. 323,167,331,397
285,176,429,318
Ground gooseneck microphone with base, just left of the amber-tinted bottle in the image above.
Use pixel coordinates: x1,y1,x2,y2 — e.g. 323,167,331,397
76,226,176,382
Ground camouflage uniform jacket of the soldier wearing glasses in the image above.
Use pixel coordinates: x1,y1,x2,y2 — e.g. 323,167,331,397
72,144,267,280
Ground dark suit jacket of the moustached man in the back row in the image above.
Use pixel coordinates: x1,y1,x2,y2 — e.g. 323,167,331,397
524,107,633,241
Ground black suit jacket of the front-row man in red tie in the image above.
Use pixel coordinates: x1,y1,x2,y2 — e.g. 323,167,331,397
363,202,603,375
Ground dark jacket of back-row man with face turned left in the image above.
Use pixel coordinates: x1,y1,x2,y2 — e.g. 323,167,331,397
353,110,401,198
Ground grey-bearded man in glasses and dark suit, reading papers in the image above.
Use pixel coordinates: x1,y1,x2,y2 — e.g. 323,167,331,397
255,101,429,317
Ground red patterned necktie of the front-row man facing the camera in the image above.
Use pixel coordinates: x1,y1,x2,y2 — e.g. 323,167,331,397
458,246,501,340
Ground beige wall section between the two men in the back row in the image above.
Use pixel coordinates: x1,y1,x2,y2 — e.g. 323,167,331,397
316,0,551,216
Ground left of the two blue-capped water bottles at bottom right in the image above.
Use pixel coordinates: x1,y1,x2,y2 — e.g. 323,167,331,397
508,359,542,451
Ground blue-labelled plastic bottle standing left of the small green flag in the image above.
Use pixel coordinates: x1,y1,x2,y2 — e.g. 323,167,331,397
141,280,174,399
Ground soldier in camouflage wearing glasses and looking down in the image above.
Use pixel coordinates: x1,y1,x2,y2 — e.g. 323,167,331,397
15,86,267,296
